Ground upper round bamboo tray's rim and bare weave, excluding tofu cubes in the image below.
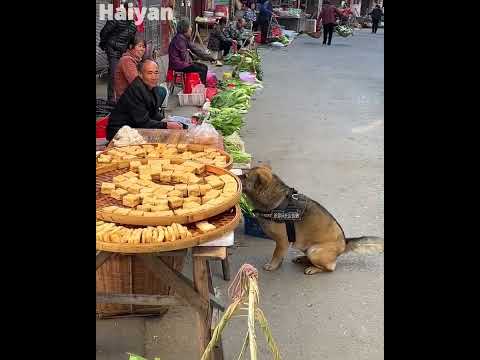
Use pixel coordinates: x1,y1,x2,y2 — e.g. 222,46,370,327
96,165,242,226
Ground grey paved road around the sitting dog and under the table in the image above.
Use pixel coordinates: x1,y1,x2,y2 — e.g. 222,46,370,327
97,29,384,360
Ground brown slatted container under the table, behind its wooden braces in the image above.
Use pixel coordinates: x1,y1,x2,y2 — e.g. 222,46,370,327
96,254,184,319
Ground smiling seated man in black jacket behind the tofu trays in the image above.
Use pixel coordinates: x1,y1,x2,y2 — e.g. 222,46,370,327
107,60,183,140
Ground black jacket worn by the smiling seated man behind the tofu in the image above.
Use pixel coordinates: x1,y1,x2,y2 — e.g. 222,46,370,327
107,76,167,140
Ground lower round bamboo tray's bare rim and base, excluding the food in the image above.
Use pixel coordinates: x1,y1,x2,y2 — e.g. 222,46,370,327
97,205,241,254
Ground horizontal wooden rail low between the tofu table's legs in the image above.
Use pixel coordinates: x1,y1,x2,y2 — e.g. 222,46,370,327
97,293,187,306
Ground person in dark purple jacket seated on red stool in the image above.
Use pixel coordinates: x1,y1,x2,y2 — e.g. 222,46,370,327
168,20,214,86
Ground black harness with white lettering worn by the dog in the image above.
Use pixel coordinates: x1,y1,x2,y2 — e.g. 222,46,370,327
254,188,308,243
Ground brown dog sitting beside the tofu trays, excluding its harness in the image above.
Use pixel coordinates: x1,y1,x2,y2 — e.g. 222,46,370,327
240,165,383,275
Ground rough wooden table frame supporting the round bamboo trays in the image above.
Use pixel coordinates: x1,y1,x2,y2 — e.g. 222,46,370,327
96,129,228,360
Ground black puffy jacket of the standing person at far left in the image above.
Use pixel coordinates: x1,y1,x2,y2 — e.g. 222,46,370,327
98,20,137,58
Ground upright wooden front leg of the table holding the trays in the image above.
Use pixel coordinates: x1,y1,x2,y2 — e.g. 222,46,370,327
193,257,215,360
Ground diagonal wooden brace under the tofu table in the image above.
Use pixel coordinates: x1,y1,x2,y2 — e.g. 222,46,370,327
137,254,209,313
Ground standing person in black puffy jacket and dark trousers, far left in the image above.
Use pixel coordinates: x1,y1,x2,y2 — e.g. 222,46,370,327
98,1,137,102
